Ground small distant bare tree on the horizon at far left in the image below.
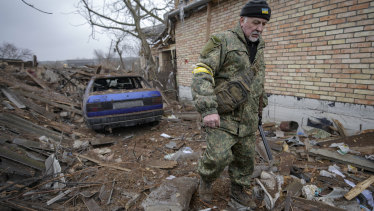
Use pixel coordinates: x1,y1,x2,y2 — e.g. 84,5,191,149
0,42,33,60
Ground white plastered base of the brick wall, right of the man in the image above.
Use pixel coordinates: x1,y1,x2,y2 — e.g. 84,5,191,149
263,95,374,135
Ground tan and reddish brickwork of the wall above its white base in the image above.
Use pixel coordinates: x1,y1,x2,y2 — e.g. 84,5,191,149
176,0,374,105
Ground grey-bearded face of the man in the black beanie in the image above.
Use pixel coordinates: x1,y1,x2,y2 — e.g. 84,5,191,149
240,17,268,42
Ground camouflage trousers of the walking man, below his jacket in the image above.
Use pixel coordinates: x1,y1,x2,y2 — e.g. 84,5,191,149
198,128,256,186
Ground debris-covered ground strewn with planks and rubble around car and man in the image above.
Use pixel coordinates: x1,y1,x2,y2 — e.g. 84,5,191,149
0,64,374,210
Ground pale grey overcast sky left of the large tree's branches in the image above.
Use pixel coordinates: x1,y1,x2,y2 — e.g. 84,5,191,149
0,0,110,61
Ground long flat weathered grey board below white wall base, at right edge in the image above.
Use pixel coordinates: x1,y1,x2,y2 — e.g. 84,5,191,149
309,148,374,172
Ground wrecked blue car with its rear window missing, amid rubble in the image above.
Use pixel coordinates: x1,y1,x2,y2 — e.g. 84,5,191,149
82,74,164,130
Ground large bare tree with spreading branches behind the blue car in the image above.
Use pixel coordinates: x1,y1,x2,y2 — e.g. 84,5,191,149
78,0,174,80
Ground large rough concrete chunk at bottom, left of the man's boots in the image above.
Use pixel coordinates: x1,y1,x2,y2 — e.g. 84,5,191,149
142,177,199,211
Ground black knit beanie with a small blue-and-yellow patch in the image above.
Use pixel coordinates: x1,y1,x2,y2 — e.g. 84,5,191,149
240,0,271,21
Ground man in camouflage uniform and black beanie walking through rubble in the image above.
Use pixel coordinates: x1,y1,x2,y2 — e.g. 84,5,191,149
191,0,271,206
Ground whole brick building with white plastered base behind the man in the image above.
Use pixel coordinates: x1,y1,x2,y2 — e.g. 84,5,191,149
153,0,374,134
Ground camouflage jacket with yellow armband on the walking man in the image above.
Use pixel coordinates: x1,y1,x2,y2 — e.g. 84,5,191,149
191,21,267,137
